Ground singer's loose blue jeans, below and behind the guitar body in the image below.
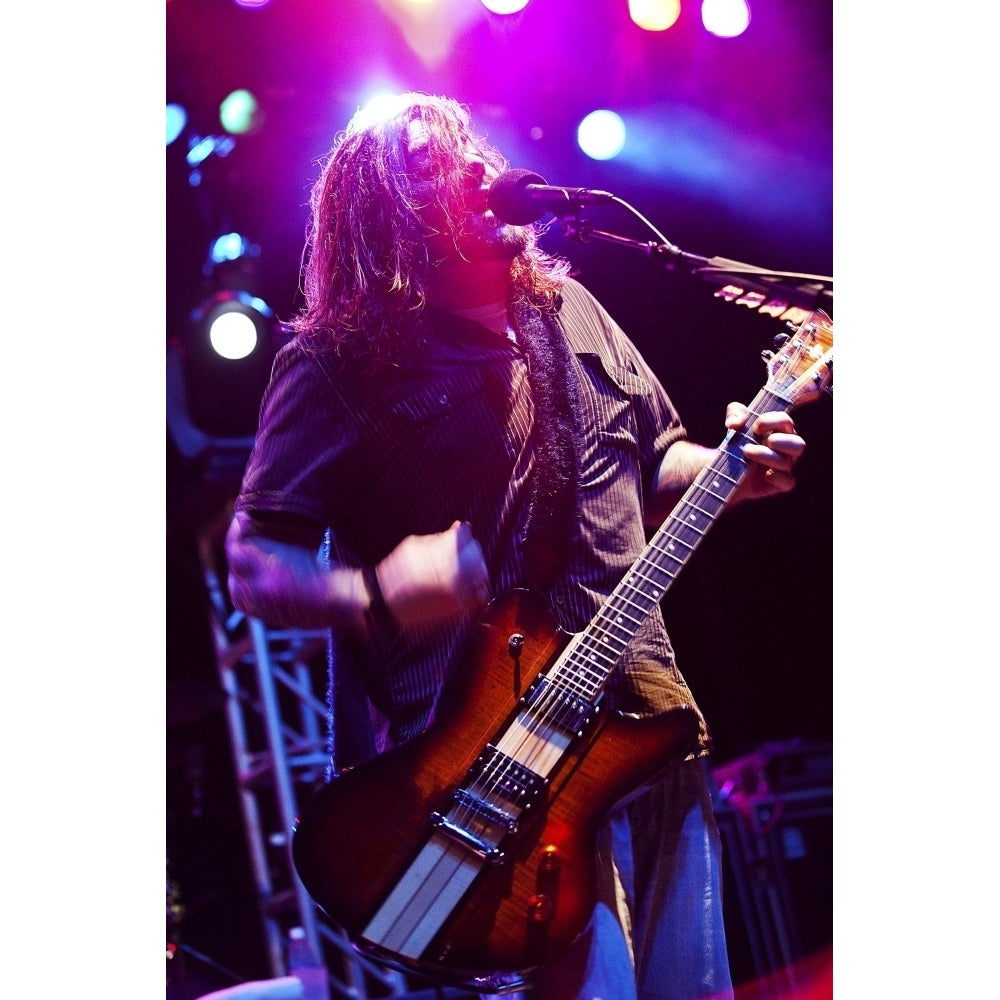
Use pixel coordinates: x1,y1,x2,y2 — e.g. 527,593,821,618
526,761,733,1000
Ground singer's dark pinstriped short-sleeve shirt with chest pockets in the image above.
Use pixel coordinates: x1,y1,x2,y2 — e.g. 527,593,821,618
236,280,708,750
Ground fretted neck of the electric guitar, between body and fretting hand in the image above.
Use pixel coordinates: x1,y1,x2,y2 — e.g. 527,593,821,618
550,388,789,702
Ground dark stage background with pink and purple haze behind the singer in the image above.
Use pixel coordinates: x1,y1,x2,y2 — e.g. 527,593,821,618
166,0,833,986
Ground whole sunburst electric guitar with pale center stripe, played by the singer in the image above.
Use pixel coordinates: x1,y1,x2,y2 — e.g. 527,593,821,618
292,311,833,993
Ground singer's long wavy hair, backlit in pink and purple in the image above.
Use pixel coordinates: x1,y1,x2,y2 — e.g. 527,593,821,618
287,93,569,361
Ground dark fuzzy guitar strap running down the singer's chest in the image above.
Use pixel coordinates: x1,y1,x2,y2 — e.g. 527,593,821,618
508,302,580,593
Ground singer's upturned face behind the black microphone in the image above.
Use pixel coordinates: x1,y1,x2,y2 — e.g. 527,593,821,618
406,120,527,262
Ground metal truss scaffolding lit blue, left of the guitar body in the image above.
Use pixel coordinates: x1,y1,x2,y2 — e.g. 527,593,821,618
198,508,408,1000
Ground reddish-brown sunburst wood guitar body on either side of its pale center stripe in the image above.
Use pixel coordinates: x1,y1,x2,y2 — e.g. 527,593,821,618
293,591,697,981
